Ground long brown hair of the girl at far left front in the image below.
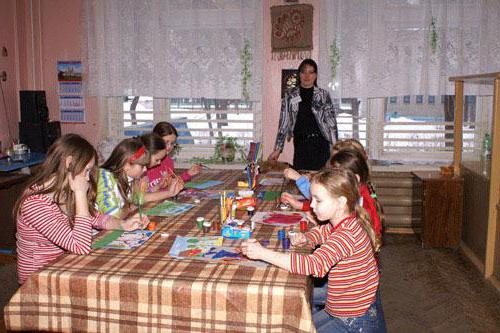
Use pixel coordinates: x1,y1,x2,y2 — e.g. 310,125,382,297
13,134,97,225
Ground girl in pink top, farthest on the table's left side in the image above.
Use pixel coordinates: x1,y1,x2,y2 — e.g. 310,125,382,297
141,133,184,202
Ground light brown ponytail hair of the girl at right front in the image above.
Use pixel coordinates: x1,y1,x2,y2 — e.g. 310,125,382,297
311,167,381,252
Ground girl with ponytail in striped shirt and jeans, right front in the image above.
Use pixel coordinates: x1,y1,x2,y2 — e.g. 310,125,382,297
242,168,385,333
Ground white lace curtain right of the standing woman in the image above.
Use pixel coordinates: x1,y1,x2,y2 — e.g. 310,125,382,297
318,0,500,97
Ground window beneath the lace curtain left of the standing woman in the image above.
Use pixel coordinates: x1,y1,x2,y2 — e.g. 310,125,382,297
120,96,261,160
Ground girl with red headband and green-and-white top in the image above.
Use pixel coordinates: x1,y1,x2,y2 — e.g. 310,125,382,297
97,138,180,217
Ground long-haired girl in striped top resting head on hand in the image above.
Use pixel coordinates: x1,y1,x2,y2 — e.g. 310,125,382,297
14,134,147,284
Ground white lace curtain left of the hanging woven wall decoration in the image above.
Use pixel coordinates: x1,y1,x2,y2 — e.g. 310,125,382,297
82,0,262,100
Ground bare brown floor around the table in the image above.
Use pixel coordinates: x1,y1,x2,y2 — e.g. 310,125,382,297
0,235,500,333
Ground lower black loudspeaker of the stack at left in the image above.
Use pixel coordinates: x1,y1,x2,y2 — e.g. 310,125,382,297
19,121,61,153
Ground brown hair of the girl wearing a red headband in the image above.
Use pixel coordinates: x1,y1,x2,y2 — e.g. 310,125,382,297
101,138,149,203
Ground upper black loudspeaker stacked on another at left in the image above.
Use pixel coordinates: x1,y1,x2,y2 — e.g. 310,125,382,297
19,90,49,123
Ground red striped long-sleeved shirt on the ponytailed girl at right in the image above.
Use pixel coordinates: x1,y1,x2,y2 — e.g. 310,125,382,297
291,215,379,318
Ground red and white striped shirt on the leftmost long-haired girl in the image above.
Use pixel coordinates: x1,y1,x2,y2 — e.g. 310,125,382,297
16,189,108,284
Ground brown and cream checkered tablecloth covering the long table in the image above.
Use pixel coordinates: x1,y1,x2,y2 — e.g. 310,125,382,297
4,170,315,332
